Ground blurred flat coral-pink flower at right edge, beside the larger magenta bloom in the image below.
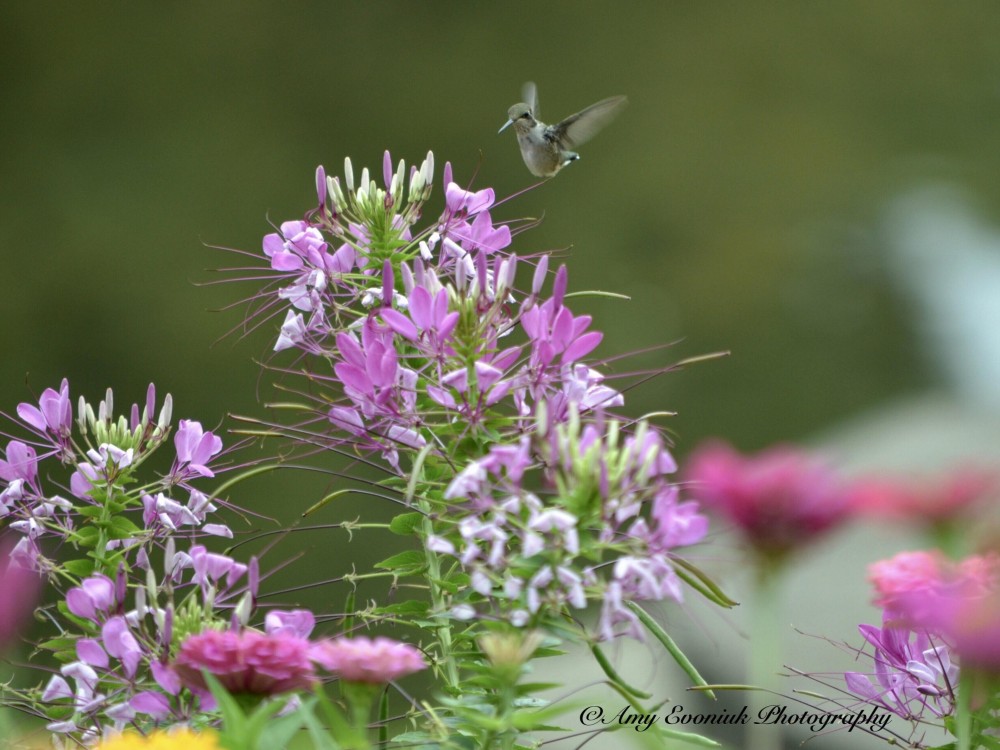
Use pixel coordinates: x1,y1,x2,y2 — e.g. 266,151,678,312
851,466,1000,524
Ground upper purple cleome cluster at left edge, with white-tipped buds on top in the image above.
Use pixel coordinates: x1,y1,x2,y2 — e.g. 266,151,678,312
0,380,232,571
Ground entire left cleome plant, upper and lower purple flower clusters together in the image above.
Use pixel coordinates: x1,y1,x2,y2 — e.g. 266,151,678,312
0,380,259,742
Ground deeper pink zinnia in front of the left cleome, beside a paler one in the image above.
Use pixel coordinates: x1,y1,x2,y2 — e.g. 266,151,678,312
174,630,317,695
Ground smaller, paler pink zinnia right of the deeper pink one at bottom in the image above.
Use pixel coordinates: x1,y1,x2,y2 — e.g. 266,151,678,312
312,636,427,685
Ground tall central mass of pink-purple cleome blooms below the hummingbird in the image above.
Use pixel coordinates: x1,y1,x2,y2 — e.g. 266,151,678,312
240,153,720,652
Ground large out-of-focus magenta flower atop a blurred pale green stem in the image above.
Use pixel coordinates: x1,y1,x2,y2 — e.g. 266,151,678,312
684,442,851,560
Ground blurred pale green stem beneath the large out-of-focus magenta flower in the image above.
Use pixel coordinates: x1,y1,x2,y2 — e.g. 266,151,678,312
747,562,783,750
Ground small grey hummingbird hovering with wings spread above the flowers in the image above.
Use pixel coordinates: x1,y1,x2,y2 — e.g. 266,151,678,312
497,81,628,177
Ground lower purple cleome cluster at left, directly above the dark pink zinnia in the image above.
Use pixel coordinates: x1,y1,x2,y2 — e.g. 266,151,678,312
41,539,258,737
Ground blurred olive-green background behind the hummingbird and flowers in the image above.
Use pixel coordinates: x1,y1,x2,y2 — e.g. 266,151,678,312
0,0,1000,748
